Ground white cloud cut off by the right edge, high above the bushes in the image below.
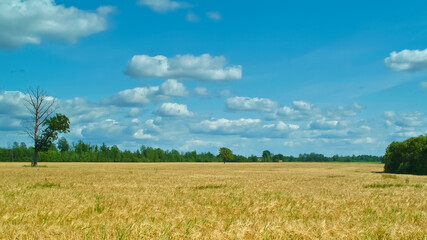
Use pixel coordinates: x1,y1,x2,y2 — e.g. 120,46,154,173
384,49,427,72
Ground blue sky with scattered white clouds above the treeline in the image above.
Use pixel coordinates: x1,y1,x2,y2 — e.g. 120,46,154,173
0,0,427,155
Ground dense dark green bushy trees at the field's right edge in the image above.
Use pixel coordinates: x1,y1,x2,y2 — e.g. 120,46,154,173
384,135,427,175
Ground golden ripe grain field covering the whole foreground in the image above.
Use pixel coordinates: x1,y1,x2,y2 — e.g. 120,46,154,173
0,163,427,239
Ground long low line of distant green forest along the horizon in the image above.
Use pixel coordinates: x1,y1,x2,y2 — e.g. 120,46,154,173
0,138,384,163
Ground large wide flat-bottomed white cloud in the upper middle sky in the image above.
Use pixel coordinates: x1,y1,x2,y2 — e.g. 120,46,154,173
125,54,242,81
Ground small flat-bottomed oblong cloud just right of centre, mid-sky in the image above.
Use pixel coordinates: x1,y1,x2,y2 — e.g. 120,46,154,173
227,97,278,112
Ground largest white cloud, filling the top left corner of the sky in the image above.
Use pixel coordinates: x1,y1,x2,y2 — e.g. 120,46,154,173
0,0,114,49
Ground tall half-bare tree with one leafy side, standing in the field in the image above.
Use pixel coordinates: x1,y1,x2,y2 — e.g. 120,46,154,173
25,87,70,167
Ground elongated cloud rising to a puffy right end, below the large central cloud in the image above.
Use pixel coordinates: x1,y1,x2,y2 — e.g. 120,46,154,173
102,79,189,107
